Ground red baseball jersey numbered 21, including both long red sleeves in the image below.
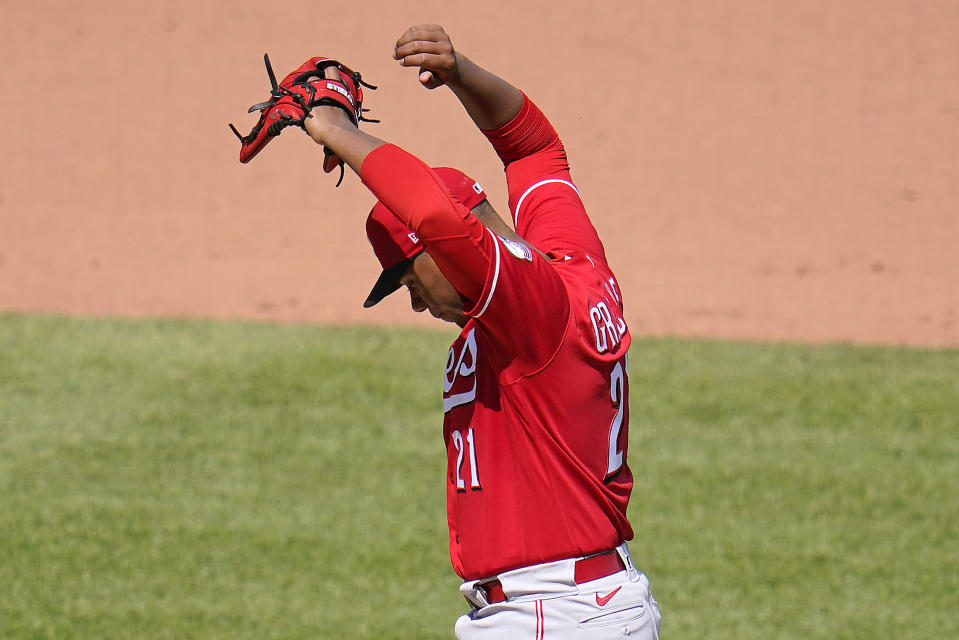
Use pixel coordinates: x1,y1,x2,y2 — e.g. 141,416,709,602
361,99,633,579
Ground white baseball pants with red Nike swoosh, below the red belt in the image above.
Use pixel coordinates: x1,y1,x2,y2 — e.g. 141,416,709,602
456,542,662,640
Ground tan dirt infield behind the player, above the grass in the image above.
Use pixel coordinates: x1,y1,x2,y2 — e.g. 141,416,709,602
0,0,959,346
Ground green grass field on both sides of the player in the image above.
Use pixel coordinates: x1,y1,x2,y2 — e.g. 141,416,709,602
0,314,959,640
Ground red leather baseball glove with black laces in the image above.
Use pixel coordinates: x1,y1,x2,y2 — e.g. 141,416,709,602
230,54,379,186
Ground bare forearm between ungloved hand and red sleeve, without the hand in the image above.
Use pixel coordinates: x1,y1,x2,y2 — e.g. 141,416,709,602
447,52,523,131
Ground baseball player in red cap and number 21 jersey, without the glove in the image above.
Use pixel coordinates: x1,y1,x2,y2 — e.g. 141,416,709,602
244,25,661,640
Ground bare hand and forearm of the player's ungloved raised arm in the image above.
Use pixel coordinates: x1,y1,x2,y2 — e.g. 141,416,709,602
393,24,523,131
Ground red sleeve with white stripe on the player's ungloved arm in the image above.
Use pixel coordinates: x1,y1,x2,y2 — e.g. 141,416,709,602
483,94,606,262
